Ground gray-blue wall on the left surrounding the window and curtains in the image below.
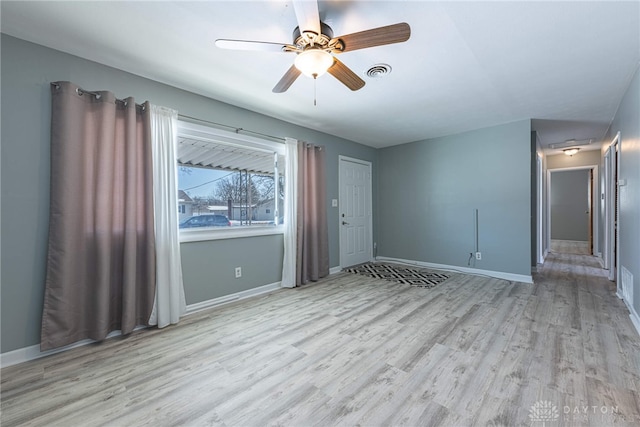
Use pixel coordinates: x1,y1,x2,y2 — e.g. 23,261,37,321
0,34,377,353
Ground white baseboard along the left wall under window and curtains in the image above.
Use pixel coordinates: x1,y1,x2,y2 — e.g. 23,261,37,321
0,282,280,368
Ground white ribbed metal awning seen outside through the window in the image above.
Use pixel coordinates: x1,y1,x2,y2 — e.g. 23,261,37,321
178,136,284,175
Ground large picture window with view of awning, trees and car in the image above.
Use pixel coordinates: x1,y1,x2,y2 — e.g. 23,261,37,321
177,122,285,241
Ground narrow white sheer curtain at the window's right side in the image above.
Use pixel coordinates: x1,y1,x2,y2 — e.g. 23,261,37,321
280,138,298,288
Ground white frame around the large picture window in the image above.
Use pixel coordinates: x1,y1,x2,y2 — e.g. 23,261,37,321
176,120,286,243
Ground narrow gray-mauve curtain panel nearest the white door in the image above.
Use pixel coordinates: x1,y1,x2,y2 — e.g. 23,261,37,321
296,142,329,286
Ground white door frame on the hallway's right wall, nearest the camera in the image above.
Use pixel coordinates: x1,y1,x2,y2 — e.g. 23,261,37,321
603,132,621,282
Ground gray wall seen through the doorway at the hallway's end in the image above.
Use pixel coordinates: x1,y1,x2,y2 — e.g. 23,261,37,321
550,169,590,242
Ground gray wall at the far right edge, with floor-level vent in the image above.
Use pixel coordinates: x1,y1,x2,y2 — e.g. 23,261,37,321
605,66,640,315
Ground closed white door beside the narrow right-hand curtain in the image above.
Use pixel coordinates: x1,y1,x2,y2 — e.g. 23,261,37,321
339,156,373,268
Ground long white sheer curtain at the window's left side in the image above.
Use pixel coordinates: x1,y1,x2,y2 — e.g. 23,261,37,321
149,105,187,328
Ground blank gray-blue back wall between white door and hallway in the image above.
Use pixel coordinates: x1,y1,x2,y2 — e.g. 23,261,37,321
378,120,531,276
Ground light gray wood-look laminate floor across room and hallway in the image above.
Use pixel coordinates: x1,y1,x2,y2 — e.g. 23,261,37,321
1,252,640,427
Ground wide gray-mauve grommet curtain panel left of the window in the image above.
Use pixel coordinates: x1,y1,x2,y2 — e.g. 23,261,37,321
40,82,155,350
